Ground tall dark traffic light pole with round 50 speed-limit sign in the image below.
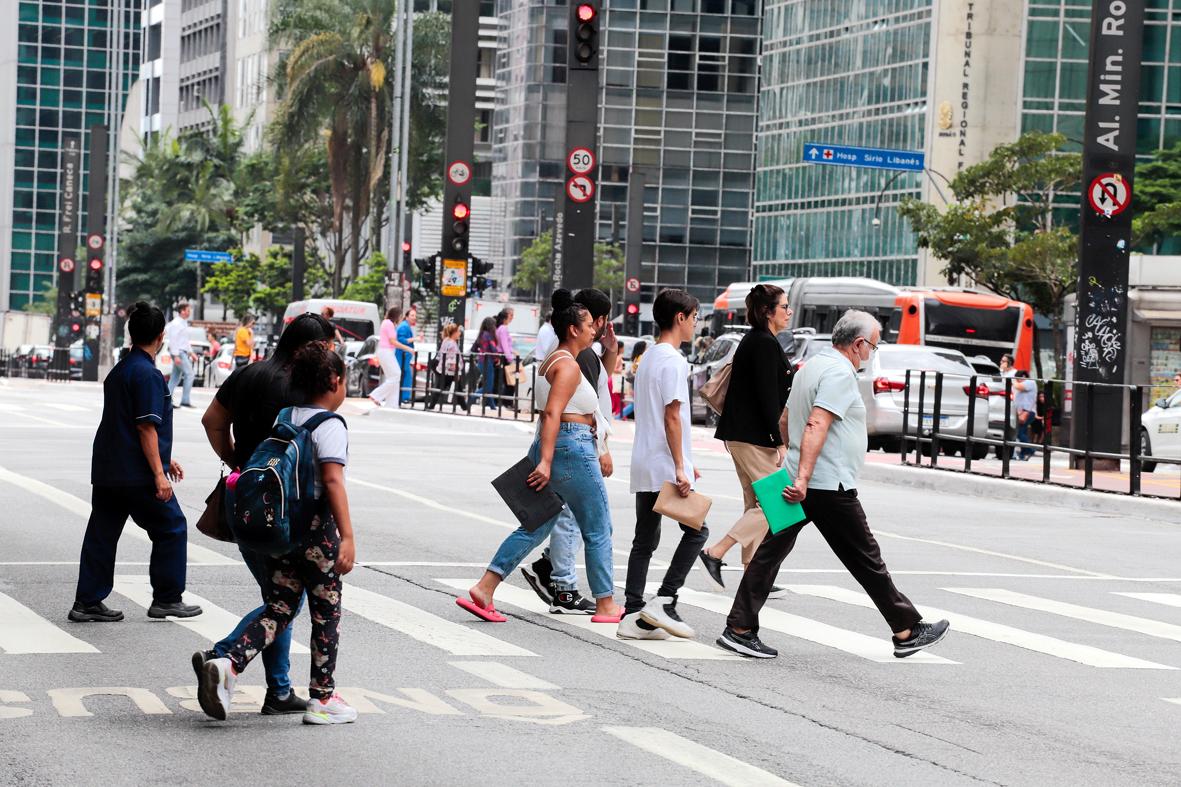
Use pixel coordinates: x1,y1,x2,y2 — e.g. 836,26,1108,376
554,0,602,290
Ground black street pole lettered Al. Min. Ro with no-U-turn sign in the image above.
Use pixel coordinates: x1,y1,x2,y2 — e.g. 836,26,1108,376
1071,0,1144,467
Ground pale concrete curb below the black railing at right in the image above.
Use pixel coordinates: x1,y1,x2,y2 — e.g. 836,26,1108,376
861,462,1181,525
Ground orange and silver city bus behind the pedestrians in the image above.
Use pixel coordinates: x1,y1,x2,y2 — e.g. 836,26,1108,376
710,277,1035,371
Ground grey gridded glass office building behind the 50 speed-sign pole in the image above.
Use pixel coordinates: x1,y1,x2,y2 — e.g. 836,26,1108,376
492,0,761,300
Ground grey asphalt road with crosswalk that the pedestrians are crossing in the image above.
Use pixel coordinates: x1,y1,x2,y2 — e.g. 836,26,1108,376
0,381,1181,787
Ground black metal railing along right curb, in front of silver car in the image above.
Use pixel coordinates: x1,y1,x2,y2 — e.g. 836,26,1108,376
901,370,1181,499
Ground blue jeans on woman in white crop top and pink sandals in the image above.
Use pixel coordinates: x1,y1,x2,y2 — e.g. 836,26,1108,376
488,423,615,598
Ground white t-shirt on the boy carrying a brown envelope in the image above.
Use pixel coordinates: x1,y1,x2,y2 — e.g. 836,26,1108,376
632,344,693,494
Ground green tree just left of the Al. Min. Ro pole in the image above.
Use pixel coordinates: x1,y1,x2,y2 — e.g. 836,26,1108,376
899,132,1082,377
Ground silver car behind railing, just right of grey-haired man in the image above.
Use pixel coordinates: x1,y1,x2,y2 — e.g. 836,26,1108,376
857,344,988,458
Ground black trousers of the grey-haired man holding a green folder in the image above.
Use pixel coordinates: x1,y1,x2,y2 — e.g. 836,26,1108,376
726,489,922,631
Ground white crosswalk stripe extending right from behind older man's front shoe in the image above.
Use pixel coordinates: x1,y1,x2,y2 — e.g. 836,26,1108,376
788,585,1176,670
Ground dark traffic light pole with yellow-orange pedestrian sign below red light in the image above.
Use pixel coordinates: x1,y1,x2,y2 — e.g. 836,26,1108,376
439,0,479,334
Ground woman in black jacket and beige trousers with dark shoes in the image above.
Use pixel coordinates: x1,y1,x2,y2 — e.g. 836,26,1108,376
702,284,791,592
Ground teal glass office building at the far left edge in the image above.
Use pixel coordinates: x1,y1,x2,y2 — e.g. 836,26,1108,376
0,0,141,310
